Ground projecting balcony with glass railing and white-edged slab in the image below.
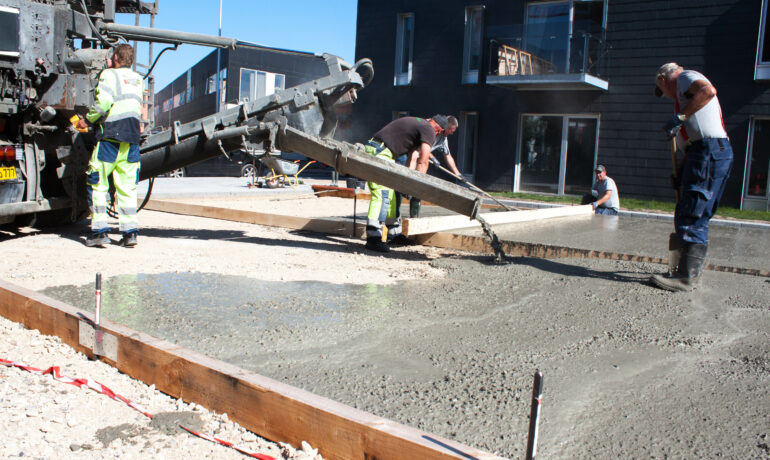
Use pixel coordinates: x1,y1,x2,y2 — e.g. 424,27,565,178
487,33,609,91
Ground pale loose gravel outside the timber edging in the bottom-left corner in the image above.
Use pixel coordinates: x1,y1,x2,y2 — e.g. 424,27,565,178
0,317,321,460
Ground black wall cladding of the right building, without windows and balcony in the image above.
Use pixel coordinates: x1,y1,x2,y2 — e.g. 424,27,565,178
353,0,770,206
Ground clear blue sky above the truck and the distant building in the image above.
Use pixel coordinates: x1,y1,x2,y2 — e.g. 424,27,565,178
117,0,357,91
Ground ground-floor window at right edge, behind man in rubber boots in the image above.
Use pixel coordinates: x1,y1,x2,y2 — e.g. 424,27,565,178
742,118,770,211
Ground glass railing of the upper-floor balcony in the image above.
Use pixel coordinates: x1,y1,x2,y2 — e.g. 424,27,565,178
488,33,609,88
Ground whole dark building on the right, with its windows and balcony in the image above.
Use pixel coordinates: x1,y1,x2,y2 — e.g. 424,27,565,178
353,0,770,210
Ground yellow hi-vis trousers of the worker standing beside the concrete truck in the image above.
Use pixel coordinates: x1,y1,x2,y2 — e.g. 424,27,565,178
86,139,140,234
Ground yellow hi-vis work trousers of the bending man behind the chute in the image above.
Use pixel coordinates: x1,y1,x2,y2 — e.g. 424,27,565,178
364,140,401,239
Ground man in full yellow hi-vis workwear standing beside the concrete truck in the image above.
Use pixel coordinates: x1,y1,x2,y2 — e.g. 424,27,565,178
77,44,144,247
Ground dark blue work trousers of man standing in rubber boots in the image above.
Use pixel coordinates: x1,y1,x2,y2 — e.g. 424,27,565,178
674,138,733,244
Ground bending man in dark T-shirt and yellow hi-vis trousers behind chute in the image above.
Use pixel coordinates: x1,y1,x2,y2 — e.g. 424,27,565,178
364,117,447,252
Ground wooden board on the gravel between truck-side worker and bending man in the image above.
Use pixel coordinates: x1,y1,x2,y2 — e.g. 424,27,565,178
144,200,366,237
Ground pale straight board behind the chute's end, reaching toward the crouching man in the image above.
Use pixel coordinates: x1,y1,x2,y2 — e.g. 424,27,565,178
403,205,593,236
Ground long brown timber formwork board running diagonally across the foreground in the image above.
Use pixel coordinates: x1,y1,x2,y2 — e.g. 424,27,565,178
0,280,500,459
